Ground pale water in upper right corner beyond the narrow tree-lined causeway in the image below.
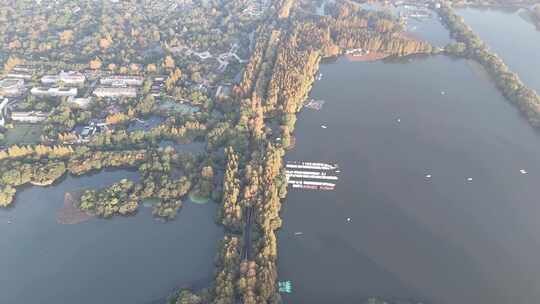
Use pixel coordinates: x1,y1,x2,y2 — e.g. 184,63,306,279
456,8,540,92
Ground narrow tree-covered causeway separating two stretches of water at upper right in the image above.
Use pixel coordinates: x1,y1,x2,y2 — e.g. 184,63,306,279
438,3,540,127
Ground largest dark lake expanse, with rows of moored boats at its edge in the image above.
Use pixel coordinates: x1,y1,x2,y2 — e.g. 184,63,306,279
279,56,540,304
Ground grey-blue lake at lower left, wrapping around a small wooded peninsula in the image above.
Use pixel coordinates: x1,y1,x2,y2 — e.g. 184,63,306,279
0,170,223,304
